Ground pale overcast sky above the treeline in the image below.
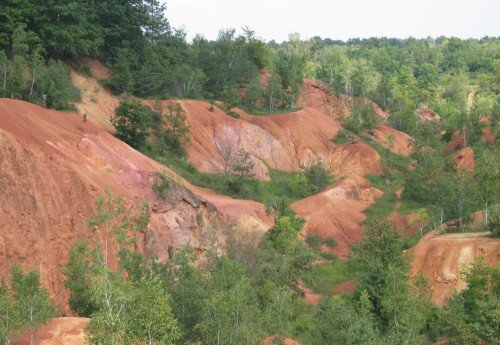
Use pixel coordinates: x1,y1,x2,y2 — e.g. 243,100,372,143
163,0,500,42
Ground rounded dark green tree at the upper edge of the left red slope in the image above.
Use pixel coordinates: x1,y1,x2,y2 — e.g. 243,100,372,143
111,98,152,148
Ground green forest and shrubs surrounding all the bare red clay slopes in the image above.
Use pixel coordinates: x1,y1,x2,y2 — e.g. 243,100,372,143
0,0,500,345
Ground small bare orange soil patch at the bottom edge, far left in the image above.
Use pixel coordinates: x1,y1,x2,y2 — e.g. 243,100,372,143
12,317,89,345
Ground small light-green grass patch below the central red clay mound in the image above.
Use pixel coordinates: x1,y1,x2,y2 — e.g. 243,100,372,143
304,260,356,296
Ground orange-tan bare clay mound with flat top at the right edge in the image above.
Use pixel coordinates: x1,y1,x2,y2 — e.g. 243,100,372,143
409,232,500,306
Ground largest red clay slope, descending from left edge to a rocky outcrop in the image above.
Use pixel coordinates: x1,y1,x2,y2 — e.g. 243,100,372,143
0,99,272,312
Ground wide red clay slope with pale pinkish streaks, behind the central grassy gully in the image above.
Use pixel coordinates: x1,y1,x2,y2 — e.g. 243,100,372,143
150,100,381,180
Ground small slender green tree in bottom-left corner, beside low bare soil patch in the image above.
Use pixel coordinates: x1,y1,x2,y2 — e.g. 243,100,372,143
10,266,55,345
